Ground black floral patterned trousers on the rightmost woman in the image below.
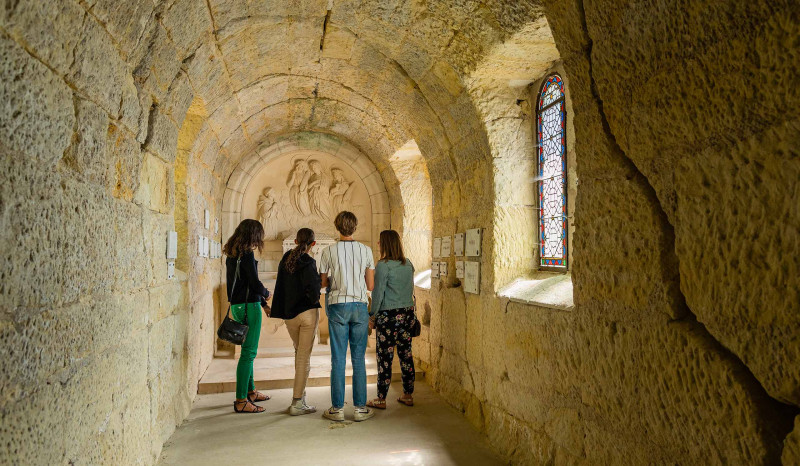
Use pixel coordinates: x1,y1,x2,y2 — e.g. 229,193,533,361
375,307,414,399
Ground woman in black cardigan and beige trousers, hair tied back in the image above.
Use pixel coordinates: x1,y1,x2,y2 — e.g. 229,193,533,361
271,228,322,416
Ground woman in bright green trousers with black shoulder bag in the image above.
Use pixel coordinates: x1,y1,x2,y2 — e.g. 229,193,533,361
222,219,269,413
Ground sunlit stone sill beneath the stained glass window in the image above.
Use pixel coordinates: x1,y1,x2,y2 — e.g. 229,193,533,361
497,272,575,311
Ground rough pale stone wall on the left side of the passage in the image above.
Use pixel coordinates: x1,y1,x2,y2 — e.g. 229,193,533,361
0,1,203,464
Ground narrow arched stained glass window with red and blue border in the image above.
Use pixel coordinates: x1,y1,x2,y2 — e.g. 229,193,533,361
536,74,567,267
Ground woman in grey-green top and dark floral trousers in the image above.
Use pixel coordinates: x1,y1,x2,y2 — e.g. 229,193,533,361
367,230,416,409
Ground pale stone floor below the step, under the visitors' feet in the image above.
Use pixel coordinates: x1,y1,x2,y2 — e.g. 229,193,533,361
159,380,503,466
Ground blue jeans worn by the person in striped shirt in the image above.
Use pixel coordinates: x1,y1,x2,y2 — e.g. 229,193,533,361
326,303,369,409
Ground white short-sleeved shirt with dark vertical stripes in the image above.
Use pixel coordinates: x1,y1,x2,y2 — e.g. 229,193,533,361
319,241,375,304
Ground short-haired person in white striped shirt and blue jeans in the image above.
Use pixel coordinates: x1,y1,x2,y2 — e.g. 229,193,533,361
319,211,375,421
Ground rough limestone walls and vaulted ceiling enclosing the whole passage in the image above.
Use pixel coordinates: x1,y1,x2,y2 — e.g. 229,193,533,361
0,0,800,464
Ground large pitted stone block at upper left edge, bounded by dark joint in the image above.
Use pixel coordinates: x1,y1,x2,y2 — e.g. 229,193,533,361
0,34,73,167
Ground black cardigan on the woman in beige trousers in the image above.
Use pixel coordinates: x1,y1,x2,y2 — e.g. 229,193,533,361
270,251,322,320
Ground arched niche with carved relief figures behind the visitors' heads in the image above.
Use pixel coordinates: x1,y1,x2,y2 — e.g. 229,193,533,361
221,133,390,274
